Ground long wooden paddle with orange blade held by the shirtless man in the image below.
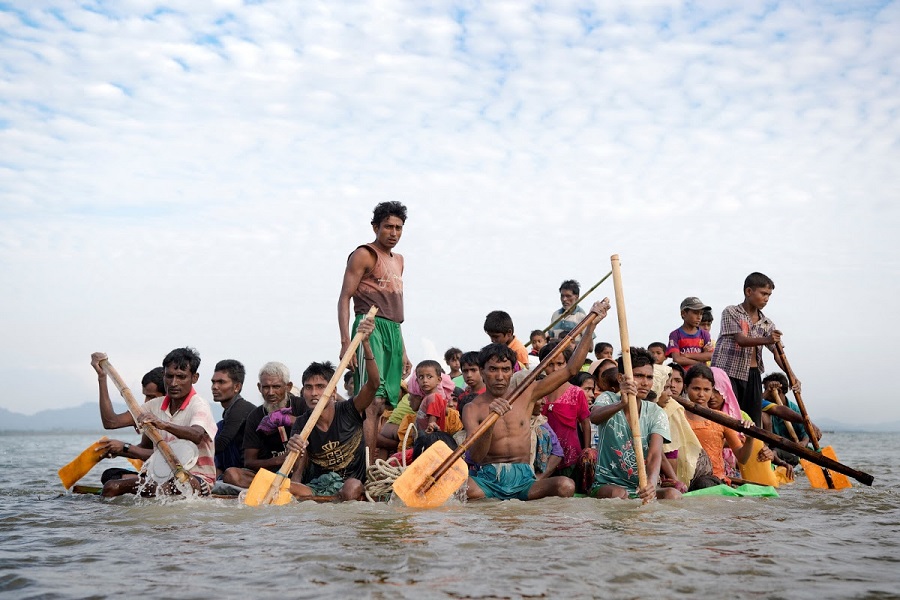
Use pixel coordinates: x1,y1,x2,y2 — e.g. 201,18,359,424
393,304,600,508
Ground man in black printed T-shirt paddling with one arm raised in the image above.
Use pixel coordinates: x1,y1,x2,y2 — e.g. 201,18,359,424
288,319,381,500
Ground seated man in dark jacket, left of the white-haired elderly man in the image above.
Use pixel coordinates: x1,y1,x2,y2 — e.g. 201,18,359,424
212,358,256,477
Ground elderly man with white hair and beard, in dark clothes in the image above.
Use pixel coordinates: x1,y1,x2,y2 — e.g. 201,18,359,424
222,362,307,488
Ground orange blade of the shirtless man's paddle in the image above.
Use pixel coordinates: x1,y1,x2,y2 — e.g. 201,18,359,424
394,442,469,508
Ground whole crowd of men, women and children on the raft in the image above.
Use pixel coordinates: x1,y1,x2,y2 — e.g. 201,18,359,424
91,202,821,501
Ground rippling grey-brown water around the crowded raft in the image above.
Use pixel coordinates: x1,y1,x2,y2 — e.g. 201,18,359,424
0,434,900,599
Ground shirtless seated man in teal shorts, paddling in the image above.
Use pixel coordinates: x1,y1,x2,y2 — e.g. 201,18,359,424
463,299,609,500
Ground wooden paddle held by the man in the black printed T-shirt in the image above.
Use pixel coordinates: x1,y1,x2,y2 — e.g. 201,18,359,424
244,306,378,506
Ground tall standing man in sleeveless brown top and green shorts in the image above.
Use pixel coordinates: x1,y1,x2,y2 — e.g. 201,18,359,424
338,202,412,457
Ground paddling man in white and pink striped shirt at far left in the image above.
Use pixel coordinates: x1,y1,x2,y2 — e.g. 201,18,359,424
91,348,216,496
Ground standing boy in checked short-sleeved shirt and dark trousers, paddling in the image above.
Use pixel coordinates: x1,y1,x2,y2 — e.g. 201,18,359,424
712,273,784,427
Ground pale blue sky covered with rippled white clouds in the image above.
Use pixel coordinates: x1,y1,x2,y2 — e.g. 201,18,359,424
0,0,900,424
